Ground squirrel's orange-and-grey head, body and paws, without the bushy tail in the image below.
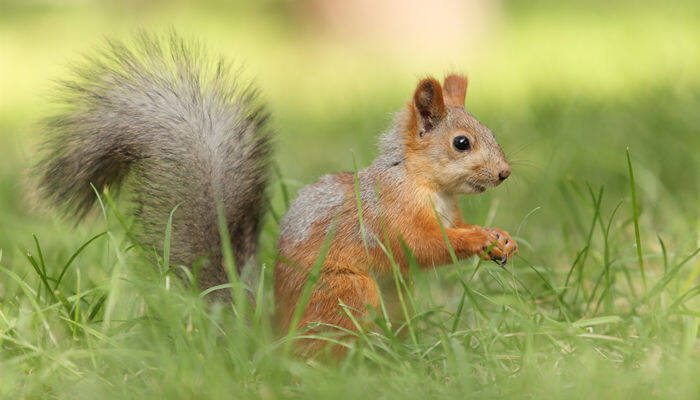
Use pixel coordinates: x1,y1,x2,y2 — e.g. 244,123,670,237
275,75,518,355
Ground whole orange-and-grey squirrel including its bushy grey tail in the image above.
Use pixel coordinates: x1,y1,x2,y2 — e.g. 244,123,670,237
36,33,518,356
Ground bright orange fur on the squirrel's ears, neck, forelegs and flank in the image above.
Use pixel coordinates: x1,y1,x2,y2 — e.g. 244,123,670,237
275,75,517,356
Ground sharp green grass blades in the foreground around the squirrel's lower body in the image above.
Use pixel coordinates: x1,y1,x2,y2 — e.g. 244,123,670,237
0,148,700,398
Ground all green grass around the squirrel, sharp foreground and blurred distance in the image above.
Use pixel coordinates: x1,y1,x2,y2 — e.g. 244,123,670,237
0,1,700,399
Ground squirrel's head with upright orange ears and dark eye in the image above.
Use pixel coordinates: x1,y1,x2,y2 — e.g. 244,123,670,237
402,75,510,194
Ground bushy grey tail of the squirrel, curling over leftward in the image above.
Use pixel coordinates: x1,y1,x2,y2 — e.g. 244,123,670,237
37,33,270,287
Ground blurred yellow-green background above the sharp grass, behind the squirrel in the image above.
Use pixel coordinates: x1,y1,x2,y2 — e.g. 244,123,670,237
0,0,700,262
